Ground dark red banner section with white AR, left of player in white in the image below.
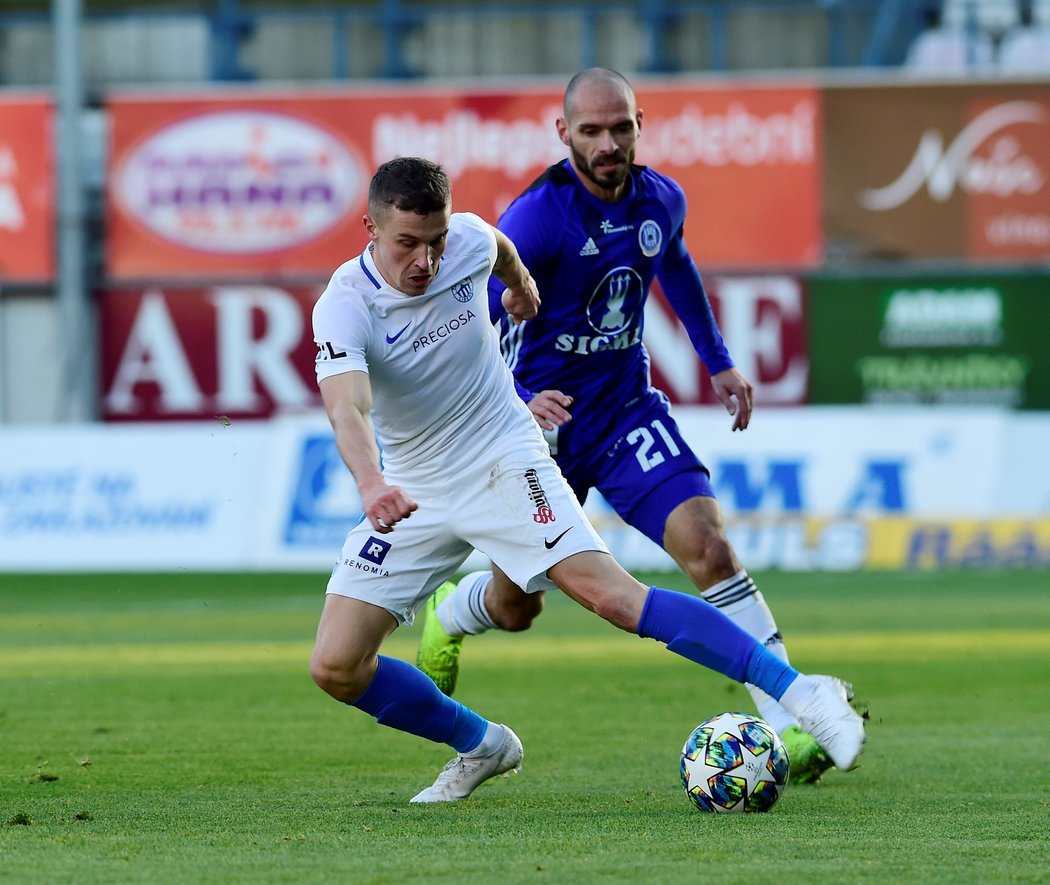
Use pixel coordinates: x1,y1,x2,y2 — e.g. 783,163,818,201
98,285,321,421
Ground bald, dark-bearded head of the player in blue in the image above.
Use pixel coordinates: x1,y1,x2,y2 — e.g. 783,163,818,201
558,81,642,203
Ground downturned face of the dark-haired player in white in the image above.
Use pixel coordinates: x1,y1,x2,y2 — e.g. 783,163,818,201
364,208,452,295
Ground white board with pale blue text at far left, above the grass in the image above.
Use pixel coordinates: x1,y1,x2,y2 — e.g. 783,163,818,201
0,421,272,571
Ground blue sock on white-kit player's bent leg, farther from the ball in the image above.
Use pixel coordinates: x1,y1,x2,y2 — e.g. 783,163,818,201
351,655,488,753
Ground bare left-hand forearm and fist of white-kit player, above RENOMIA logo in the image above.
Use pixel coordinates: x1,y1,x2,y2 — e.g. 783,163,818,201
319,372,418,534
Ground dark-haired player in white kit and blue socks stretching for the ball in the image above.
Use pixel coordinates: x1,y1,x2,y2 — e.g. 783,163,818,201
311,157,864,802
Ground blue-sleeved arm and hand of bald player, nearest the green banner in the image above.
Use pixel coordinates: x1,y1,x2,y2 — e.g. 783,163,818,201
659,228,755,430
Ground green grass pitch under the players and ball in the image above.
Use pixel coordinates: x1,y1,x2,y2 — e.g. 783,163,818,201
0,572,1050,883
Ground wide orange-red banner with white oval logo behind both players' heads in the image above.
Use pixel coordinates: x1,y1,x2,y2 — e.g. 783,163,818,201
106,83,821,280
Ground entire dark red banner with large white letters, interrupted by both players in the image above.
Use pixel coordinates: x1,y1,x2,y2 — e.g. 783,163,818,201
98,276,810,421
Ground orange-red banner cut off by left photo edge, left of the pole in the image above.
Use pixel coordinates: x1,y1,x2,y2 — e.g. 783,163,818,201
0,97,55,283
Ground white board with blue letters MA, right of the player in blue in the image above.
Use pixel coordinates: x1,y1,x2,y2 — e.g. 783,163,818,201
676,406,999,517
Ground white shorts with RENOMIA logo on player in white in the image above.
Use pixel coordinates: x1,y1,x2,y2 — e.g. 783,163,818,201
328,441,609,625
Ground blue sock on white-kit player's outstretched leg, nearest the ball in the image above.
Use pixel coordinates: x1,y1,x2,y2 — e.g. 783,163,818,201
638,587,798,700
